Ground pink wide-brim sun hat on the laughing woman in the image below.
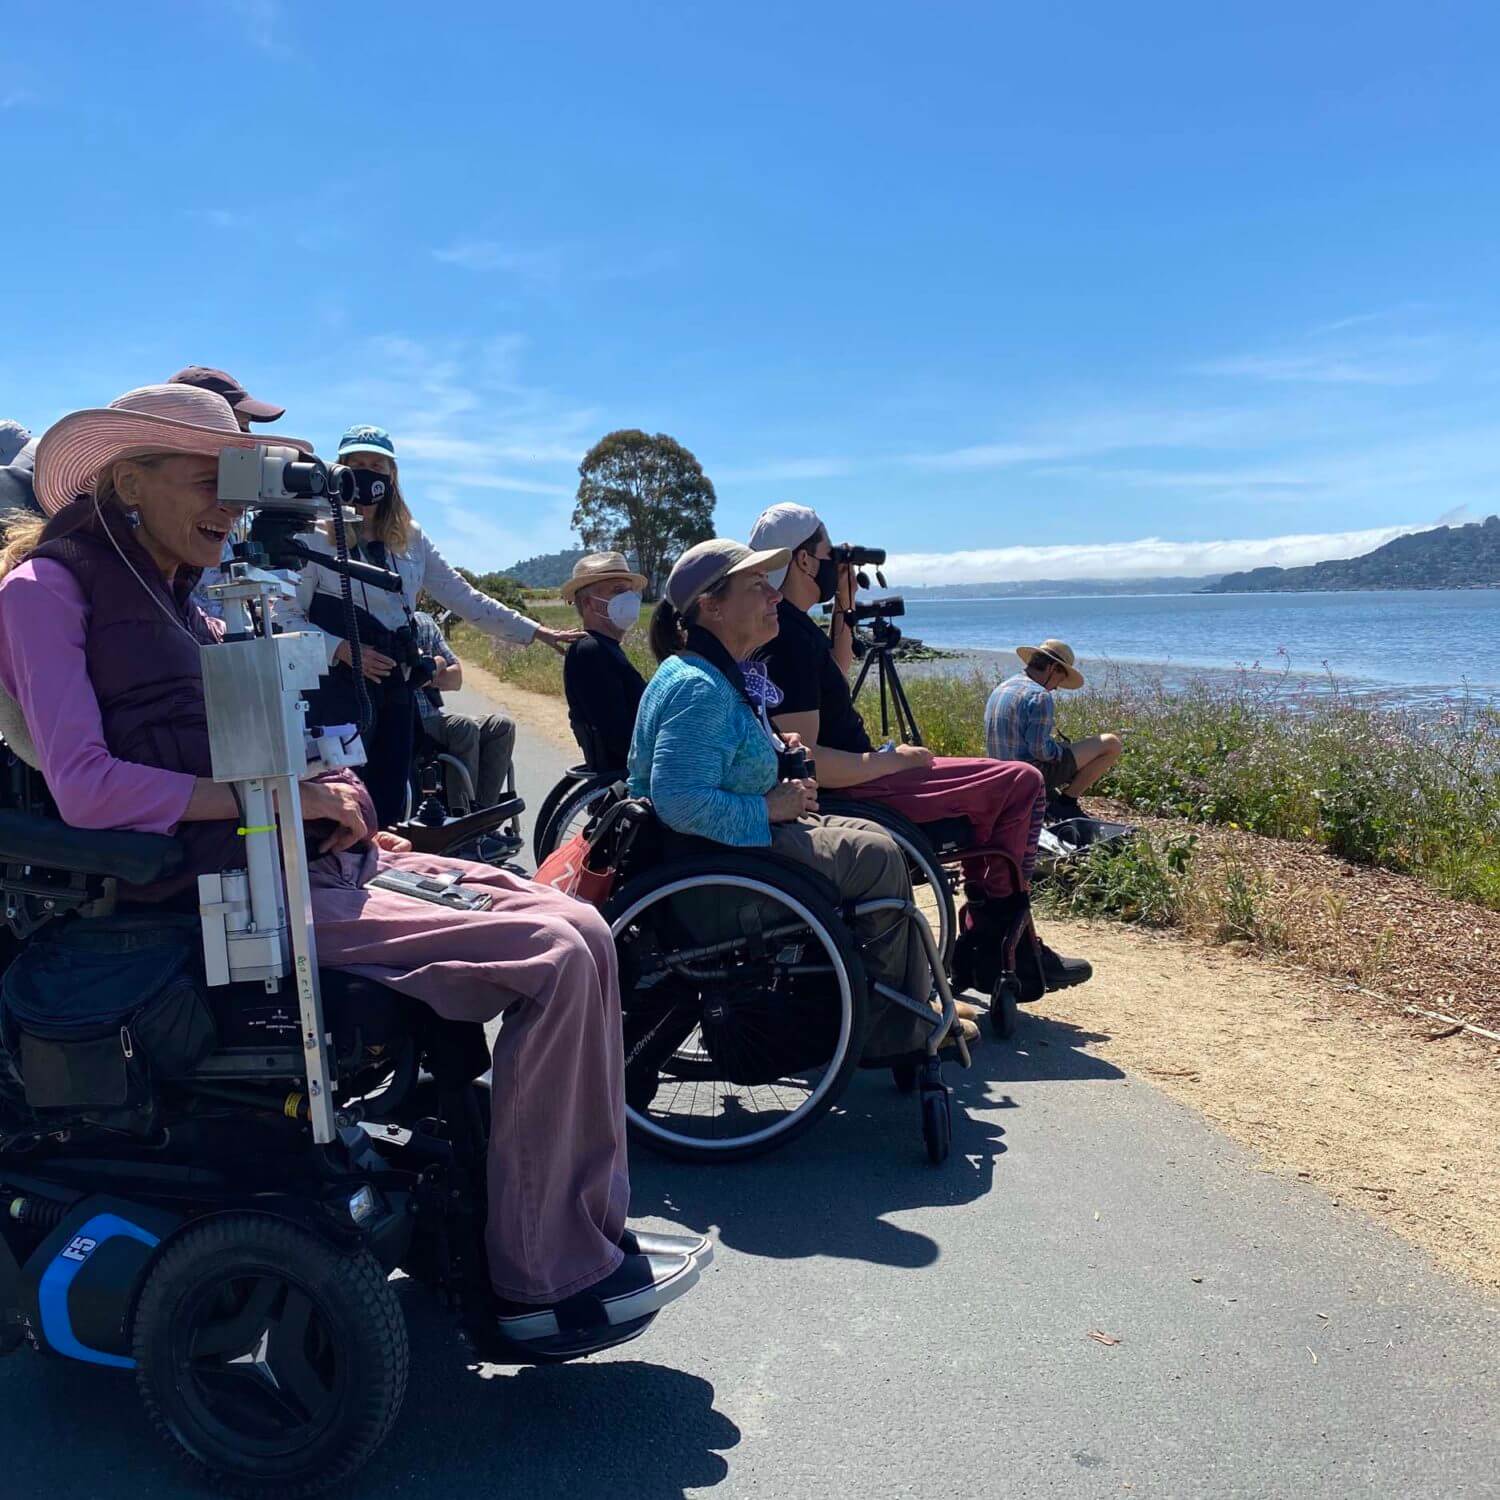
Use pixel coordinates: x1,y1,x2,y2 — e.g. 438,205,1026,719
33,386,312,516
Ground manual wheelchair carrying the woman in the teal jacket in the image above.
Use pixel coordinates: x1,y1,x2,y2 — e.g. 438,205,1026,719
549,785,969,1164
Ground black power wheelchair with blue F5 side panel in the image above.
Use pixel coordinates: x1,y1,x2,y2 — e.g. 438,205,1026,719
0,720,636,1497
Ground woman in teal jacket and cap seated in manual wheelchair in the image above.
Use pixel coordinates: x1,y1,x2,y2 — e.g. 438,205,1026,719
630,537,972,1058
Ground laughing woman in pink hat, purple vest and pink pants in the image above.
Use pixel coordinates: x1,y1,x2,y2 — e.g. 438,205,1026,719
0,386,692,1340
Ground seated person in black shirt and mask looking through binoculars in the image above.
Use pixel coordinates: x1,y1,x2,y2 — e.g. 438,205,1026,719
750,504,1094,998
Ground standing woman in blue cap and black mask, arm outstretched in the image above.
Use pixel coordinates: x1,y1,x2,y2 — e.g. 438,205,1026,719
299,426,584,828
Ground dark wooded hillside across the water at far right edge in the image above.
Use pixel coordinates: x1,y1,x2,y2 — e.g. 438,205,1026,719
1203,516,1500,594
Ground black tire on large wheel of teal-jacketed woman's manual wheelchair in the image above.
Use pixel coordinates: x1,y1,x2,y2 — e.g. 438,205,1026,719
603,849,869,1164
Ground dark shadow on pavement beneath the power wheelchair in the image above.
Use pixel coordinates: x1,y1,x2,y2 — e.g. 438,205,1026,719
0,1283,740,1500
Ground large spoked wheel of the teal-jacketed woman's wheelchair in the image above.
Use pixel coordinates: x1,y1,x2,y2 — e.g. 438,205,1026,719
605,852,866,1161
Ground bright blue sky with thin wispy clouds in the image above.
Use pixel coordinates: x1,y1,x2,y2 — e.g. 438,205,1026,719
0,0,1500,582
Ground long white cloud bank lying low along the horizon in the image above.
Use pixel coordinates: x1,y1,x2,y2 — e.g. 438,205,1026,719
885,525,1427,588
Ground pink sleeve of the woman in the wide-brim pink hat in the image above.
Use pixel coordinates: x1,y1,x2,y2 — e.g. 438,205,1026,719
0,558,195,834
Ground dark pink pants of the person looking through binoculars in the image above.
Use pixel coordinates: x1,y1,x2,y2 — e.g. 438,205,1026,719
839,756,1047,896
